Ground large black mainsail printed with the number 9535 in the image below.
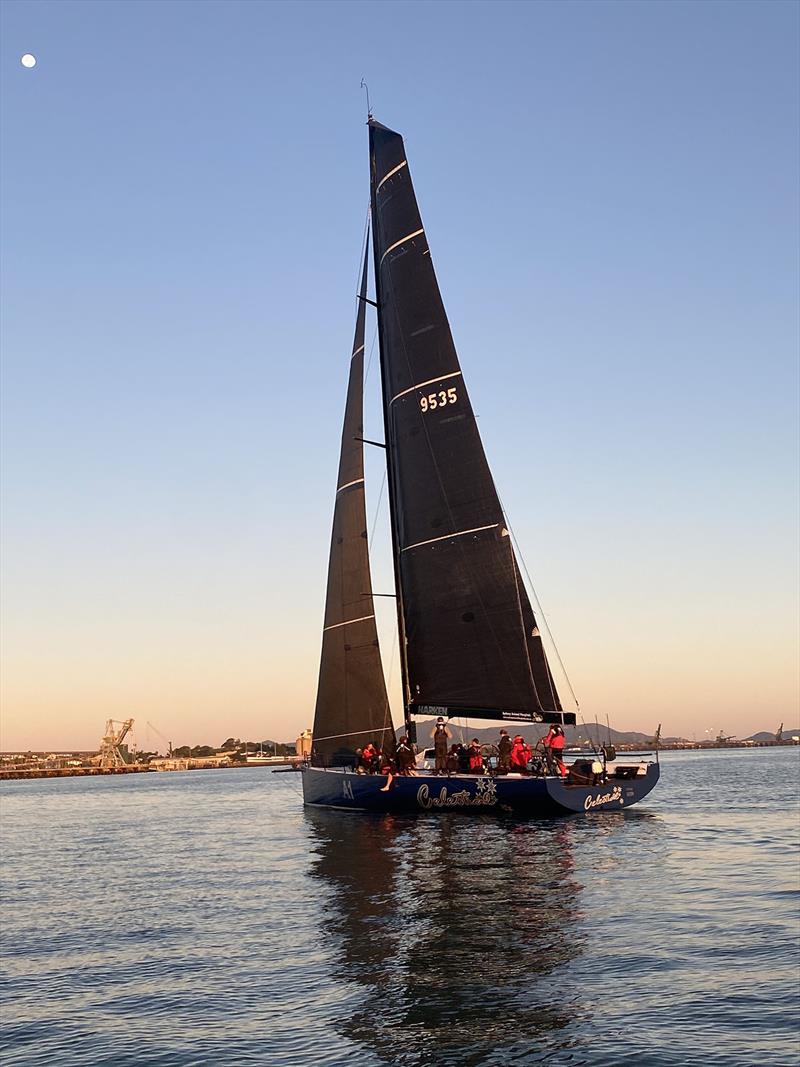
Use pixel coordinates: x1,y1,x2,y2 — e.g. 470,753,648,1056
369,121,575,723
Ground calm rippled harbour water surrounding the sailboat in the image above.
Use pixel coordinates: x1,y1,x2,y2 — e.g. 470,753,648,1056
0,749,800,1067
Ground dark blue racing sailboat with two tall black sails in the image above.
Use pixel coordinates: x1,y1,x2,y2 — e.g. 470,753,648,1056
303,114,659,816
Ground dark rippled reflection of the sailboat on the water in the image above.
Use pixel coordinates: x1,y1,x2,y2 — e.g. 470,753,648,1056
306,809,588,1054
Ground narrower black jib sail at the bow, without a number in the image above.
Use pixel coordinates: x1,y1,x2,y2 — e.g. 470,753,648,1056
311,236,395,766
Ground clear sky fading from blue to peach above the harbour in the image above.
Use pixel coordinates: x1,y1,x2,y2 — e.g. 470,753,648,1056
0,0,800,748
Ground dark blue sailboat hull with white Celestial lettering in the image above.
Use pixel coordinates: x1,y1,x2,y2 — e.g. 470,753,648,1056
303,763,659,817
